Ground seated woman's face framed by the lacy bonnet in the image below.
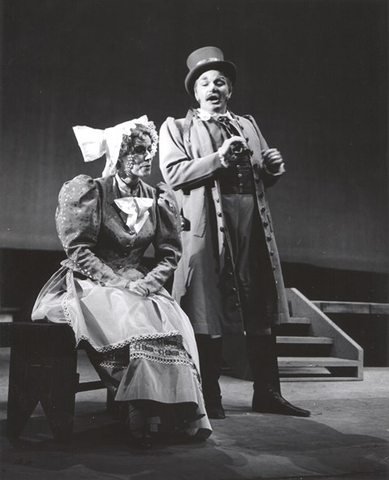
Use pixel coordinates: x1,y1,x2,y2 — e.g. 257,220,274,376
118,134,153,178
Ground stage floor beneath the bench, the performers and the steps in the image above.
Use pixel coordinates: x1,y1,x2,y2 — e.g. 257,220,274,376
0,348,389,480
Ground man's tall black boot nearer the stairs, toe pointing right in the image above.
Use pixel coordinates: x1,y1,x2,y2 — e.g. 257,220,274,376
246,335,310,417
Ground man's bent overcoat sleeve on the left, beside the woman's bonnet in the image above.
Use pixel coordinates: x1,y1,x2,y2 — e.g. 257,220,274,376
159,117,223,190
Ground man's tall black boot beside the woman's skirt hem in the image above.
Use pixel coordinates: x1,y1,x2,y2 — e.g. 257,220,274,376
196,335,226,419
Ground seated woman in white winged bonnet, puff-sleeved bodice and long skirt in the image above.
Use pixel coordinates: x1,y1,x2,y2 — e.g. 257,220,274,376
32,116,212,448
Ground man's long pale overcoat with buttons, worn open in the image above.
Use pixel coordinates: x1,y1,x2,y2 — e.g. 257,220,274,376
160,110,289,335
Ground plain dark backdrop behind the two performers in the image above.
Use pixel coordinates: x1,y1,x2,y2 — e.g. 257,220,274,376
0,0,388,273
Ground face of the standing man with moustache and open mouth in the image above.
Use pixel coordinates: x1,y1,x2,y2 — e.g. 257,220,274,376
195,70,231,113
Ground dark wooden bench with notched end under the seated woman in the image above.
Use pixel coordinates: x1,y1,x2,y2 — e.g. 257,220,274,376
6,321,115,442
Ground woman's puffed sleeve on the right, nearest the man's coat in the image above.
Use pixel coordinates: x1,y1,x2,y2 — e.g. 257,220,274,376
129,183,182,294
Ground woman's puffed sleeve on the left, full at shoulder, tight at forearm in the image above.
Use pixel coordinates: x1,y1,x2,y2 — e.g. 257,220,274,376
55,175,128,287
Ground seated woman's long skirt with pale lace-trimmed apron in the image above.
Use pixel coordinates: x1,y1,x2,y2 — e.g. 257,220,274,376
32,267,212,438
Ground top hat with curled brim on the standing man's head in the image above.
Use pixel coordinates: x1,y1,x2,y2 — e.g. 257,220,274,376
185,47,236,96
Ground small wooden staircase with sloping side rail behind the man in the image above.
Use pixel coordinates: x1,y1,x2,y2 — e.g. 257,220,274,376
223,288,363,381
